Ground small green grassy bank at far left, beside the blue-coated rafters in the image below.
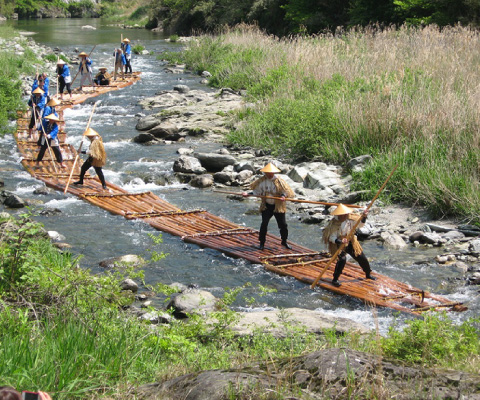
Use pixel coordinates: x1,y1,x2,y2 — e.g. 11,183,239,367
0,25,36,136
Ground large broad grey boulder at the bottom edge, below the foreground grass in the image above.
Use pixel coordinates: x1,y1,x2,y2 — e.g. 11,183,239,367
136,348,480,400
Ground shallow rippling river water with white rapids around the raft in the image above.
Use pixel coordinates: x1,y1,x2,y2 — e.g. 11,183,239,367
0,19,480,333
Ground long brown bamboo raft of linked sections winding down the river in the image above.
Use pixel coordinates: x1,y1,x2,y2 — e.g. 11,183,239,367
15,73,467,314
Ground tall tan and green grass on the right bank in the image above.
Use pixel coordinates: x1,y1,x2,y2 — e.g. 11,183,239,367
163,26,480,223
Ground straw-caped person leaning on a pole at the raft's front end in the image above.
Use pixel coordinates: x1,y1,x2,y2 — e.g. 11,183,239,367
322,204,376,287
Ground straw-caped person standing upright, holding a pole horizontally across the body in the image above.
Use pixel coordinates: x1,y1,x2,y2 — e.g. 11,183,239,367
243,163,295,250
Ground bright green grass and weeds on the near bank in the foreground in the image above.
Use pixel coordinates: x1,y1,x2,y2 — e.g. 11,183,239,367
0,214,480,400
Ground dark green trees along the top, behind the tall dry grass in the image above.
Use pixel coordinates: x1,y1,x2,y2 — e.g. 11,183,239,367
150,0,480,36
